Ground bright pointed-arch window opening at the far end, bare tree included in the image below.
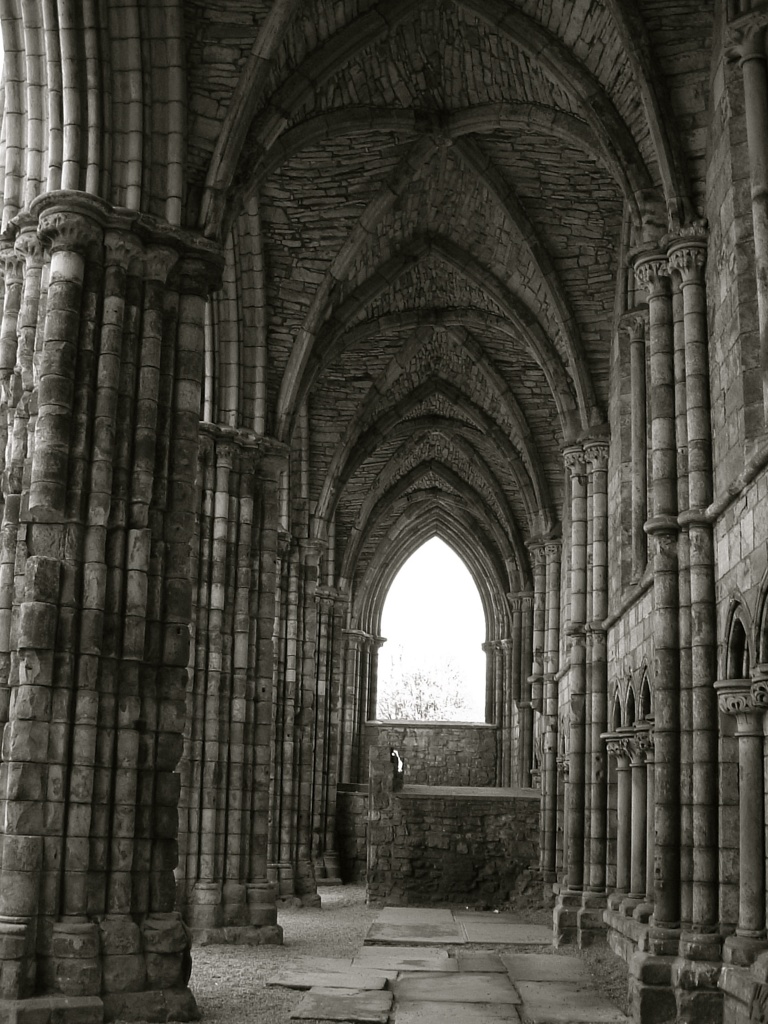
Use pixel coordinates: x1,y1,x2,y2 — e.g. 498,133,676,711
376,538,485,722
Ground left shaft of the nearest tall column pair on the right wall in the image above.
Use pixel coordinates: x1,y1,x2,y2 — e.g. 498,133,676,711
635,253,680,954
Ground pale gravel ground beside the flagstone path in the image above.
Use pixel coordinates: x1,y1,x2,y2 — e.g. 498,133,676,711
189,886,628,1024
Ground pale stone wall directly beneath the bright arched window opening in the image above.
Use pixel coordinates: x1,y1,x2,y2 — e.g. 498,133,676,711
366,722,498,785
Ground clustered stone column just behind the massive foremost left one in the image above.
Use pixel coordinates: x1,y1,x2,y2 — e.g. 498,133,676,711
177,424,285,943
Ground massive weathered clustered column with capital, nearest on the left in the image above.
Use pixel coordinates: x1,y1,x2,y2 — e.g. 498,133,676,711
0,191,225,1020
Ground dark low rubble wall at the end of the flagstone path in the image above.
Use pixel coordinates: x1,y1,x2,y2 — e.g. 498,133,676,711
366,759,539,905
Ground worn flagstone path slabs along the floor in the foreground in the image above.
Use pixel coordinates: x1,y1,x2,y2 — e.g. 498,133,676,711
268,907,629,1024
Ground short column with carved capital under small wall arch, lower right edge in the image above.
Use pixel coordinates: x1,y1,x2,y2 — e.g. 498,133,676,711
715,679,768,966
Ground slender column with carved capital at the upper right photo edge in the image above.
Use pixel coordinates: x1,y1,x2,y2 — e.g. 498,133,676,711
727,17,768,423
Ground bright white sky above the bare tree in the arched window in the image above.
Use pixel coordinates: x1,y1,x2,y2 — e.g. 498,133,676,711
379,538,485,722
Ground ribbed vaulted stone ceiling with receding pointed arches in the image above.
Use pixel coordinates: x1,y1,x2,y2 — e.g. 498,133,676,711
186,0,712,622
